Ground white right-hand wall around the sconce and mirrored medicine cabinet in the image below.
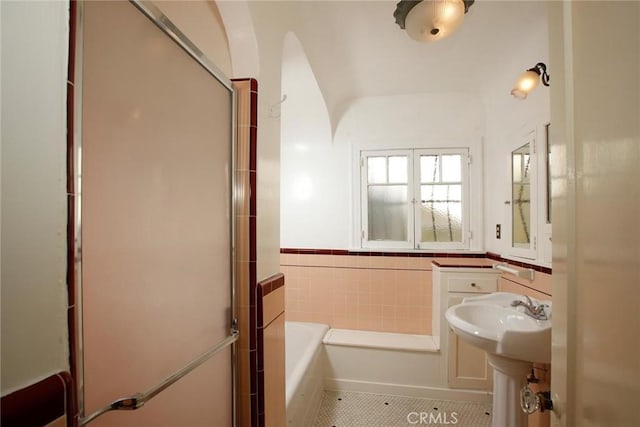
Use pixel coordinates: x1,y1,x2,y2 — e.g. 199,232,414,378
482,7,554,266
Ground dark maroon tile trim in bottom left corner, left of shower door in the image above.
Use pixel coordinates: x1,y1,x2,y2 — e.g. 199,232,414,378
0,372,75,427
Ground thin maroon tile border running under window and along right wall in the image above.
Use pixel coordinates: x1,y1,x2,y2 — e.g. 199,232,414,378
280,248,552,274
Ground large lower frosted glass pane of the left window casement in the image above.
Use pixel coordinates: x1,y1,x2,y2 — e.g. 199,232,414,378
368,185,408,241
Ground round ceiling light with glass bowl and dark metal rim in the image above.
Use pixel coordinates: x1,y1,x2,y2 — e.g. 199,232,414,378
393,0,475,42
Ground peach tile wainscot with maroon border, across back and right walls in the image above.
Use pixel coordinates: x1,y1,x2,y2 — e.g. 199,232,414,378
280,248,551,427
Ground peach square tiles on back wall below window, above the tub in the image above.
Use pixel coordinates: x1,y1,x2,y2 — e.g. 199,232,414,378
280,253,432,335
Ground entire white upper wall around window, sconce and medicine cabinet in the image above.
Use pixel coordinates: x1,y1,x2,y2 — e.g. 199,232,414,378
280,5,553,265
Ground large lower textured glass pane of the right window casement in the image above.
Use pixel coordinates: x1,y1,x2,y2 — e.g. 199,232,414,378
420,185,462,242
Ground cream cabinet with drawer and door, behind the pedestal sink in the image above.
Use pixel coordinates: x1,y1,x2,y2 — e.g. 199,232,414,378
433,266,500,391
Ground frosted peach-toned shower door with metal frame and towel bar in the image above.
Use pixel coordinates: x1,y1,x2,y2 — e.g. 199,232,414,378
74,1,237,427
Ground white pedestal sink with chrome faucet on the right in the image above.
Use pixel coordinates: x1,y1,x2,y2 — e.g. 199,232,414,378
445,292,551,427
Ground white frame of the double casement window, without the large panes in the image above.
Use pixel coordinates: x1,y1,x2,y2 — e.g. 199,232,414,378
358,147,471,250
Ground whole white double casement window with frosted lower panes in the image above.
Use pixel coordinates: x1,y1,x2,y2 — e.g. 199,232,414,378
360,149,469,249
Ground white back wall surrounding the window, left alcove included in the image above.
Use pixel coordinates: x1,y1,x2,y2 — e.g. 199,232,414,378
281,83,484,249
